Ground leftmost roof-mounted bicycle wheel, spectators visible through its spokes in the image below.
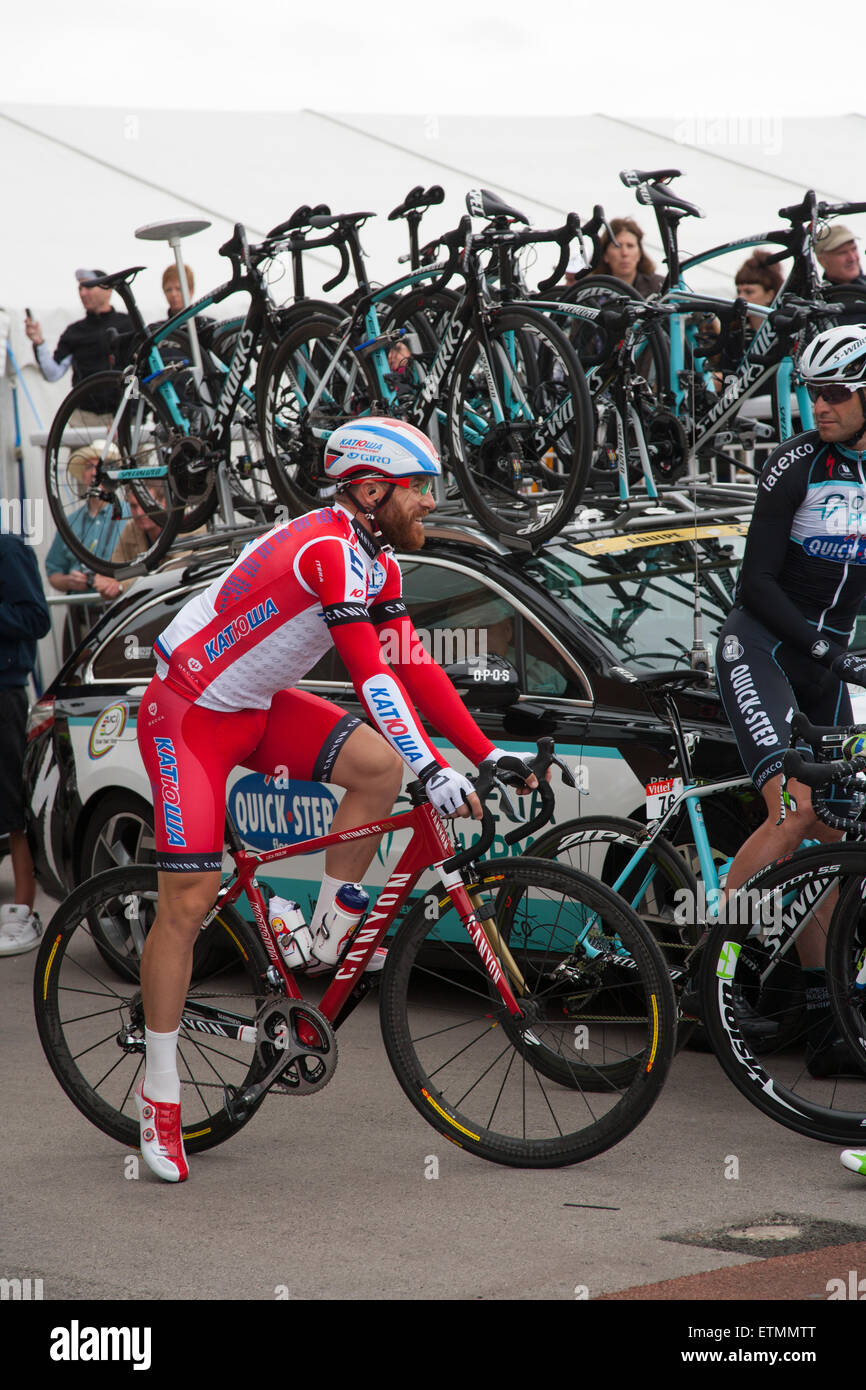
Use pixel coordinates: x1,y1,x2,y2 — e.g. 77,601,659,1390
44,371,183,574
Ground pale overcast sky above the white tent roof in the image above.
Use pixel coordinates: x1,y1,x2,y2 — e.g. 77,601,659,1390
0,0,866,117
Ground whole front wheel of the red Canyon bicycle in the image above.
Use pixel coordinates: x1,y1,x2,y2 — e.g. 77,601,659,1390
381,858,676,1168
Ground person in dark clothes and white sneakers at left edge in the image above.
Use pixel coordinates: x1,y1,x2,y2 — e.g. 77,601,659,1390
0,534,50,955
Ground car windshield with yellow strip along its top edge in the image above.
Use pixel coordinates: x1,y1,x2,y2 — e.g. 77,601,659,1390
527,521,748,671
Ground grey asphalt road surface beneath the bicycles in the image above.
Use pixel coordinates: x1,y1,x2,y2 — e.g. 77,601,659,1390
0,862,866,1302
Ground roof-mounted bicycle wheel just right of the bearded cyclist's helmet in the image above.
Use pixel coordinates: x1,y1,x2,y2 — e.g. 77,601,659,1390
448,309,594,545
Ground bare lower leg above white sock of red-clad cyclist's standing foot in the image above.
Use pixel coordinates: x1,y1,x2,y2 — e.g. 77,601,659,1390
142,872,220,1033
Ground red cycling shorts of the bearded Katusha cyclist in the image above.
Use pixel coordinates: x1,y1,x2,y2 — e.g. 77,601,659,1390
138,676,360,873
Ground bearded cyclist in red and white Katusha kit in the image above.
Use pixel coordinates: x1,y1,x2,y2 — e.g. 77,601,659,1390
136,417,537,1182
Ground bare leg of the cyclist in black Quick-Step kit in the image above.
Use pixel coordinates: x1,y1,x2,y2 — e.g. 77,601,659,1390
726,774,842,966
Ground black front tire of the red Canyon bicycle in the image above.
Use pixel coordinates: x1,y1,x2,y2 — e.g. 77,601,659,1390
379,858,676,1168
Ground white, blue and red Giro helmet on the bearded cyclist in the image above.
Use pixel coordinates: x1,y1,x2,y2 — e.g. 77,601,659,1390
325,416,442,488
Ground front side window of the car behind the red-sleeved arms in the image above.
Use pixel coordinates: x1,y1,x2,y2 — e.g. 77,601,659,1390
403,560,587,699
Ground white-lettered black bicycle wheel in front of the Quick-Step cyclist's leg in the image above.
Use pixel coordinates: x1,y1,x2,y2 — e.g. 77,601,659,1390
701,844,866,1144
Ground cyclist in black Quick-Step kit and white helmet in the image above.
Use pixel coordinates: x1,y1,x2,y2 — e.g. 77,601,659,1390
716,327,866,1170
